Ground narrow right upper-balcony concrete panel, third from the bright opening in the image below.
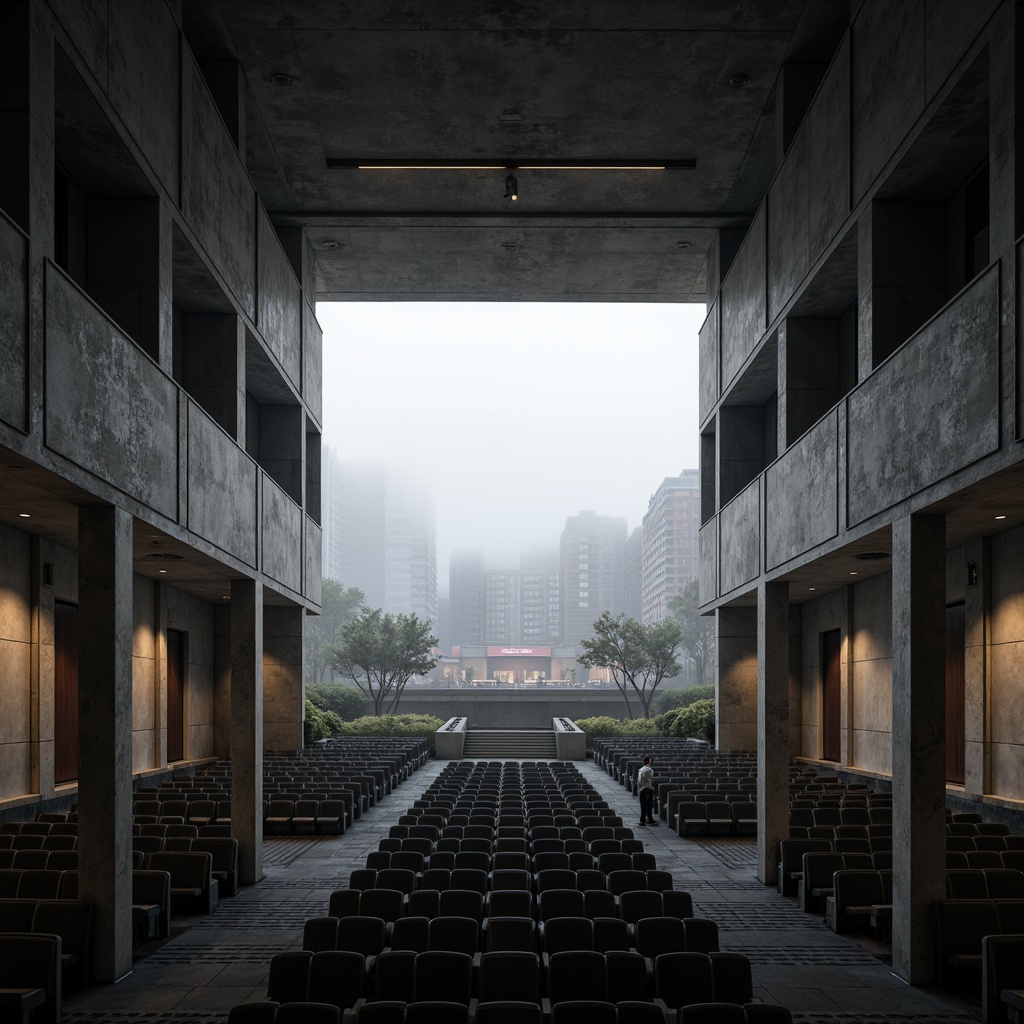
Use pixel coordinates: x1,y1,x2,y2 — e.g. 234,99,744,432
767,123,806,322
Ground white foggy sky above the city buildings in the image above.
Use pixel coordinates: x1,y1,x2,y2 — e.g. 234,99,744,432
316,302,706,581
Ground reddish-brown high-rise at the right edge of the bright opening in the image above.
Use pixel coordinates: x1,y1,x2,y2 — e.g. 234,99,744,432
641,469,700,624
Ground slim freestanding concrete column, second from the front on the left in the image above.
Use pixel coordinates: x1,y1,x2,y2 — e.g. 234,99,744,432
231,579,263,885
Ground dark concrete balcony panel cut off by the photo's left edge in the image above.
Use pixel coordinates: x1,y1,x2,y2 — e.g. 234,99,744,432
0,214,29,431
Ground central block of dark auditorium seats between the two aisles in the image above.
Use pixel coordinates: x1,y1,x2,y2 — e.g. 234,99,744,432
229,762,791,1024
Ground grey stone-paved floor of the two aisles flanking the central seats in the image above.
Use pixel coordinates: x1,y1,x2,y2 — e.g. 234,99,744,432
65,762,981,1024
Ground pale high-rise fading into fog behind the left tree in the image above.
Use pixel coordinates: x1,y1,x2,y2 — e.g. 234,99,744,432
323,464,437,625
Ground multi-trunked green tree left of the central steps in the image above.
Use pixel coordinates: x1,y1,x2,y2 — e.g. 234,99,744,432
331,608,437,715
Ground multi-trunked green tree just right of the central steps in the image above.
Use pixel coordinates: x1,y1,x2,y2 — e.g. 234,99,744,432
577,611,681,718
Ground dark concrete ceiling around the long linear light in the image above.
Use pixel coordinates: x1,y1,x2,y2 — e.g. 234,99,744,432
183,0,850,302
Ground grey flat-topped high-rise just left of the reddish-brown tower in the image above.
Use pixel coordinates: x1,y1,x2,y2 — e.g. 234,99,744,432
560,512,626,646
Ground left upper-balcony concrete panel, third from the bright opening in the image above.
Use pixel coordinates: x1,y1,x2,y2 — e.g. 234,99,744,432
181,53,256,317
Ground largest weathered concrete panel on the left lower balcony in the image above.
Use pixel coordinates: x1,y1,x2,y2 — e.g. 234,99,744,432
44,263,178,519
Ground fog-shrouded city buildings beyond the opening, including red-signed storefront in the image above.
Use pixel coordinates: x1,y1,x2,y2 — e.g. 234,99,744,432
322,446,700,686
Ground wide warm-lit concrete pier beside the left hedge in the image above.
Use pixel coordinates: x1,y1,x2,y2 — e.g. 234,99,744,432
263,605,305,751
